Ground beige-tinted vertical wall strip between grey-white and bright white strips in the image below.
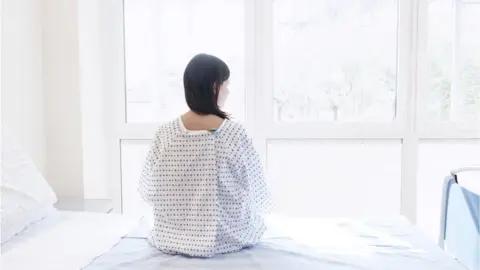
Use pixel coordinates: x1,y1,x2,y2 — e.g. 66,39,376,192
42,0,84,198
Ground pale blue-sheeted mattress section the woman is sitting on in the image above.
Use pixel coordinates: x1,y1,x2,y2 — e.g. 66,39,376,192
84,216,466,270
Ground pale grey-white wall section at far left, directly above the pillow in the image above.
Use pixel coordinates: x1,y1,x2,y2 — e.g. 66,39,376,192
1,0,47,174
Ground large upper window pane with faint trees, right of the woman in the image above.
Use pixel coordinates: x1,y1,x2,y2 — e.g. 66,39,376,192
273,0,398,122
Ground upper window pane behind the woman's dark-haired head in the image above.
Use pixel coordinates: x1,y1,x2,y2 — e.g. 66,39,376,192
125,0,245,122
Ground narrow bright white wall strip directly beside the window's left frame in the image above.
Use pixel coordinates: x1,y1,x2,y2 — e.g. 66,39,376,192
78,0,109,198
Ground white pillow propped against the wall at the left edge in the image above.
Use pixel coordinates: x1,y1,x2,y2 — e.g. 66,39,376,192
1,127,57,243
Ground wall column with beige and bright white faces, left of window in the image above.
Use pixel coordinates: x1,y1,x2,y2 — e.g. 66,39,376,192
42,0,109,198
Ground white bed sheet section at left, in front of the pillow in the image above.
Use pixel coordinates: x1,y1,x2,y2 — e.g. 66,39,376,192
1,211,138,270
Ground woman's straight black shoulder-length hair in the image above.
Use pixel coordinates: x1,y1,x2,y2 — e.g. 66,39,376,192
183,54,230,119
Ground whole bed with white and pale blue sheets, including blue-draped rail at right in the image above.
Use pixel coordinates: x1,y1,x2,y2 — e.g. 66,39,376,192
2,167,480,270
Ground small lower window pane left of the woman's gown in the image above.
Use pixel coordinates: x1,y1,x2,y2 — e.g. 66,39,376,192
121,140,150,215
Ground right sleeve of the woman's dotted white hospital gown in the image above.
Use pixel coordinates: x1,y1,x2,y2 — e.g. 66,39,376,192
237,129,273,214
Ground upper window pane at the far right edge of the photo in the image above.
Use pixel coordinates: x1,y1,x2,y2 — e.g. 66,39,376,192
426,0,480,121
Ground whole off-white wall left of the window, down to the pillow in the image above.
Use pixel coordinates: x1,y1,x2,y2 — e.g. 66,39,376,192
1,0,115,198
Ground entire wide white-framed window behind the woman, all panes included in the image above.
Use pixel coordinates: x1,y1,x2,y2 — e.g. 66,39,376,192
104,0,480,238
